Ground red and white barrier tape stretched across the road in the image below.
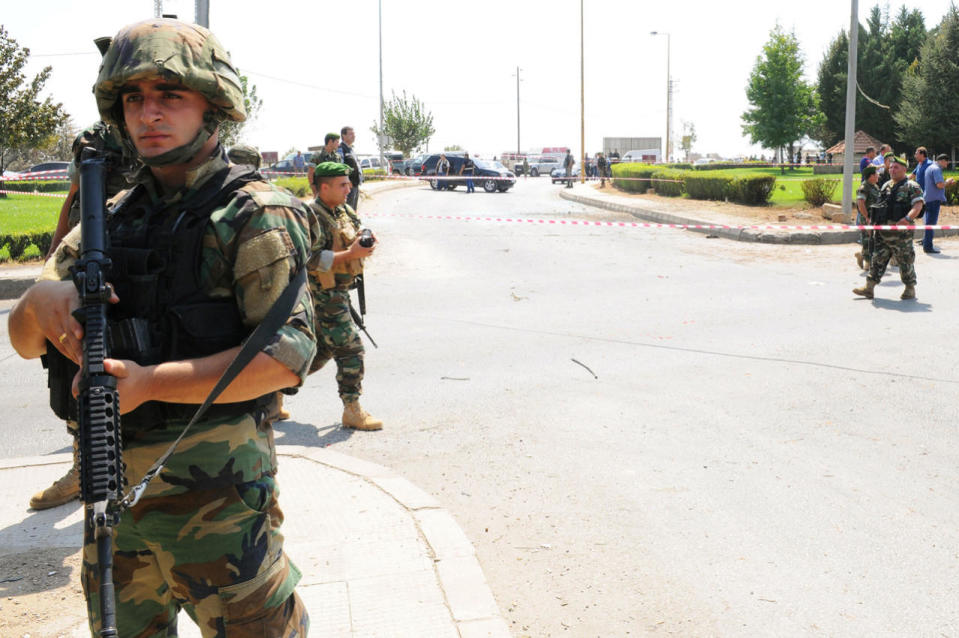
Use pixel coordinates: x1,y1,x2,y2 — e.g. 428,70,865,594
363,213,959,232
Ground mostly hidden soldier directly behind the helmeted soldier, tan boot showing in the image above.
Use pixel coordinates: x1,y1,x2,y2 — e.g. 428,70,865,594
30,120,136,510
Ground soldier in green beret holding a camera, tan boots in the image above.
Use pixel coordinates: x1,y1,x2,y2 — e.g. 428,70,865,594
309,162,383,430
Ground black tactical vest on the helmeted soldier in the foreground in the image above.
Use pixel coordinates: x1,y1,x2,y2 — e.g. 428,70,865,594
48,165,276,431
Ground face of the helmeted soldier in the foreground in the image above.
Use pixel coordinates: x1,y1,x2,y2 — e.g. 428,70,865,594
120,79,212,157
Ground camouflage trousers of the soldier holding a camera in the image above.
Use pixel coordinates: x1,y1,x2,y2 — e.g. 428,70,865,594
310,290,364,403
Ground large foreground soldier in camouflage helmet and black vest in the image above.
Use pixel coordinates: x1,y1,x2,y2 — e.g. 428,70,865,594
10,19,315,638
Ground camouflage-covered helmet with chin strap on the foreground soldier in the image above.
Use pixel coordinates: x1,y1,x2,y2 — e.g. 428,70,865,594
93,18,246,166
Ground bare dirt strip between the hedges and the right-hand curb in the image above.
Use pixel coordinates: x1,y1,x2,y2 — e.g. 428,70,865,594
592,184,959,226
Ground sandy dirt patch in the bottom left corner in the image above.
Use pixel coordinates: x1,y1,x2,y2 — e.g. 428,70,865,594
0,548,86,638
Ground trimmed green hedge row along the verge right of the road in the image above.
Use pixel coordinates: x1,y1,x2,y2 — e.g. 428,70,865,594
613,164,776,206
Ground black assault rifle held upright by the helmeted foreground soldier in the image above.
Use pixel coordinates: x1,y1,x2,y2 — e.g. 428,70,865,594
71,148,124,637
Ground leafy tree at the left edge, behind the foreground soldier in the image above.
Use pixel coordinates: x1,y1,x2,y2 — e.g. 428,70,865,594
0,25,67,175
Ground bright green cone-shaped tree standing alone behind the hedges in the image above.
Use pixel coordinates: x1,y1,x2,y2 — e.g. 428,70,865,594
742,24,821,170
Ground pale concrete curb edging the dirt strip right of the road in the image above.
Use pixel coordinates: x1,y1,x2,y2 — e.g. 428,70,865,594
559,190,959,246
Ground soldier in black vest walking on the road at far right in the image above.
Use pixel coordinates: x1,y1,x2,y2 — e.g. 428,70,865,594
853,157,922,299
